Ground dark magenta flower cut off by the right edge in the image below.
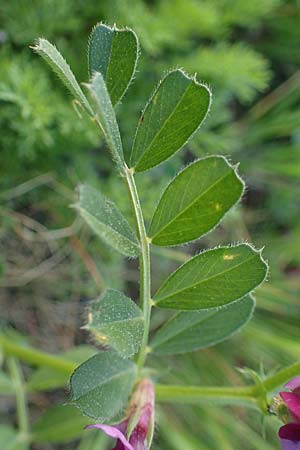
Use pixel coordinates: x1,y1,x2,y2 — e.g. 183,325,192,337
278,377,300,450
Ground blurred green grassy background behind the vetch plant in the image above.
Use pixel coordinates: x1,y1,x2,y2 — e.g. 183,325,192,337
0,0,300,450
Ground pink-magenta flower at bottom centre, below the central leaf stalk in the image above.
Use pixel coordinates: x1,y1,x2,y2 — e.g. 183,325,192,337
86,378,154,450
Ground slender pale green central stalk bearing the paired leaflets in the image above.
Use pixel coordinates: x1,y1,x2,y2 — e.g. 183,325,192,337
125,167,152,374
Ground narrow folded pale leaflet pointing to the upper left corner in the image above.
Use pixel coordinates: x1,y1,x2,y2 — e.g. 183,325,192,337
32,38,94,116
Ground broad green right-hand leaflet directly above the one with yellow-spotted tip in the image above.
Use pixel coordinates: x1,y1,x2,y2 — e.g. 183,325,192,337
149,156,244,246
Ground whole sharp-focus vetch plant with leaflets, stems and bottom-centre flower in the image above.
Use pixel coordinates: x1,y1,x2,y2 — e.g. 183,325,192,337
8,23,299,450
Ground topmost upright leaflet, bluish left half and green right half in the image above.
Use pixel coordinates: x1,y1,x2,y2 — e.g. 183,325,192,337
88,23,139,105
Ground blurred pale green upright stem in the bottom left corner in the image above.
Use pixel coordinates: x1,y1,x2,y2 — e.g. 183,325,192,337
7,357,29,442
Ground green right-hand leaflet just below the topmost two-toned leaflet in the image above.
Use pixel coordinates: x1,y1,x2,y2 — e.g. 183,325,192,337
130,70,211,172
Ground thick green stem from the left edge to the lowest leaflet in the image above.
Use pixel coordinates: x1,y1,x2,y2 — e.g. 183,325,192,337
0,335,78,374
